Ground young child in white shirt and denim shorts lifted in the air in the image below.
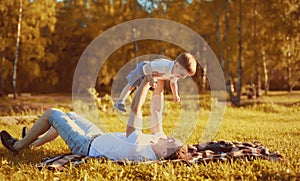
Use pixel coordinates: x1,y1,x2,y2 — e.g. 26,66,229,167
114,53,197,112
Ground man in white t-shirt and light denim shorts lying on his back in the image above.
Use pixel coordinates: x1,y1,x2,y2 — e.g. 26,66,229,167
1,78,188,161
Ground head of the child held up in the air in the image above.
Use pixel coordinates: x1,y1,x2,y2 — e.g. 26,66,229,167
173,53,197,78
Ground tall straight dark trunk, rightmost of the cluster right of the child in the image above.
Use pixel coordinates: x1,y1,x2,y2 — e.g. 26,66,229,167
235,0,243,105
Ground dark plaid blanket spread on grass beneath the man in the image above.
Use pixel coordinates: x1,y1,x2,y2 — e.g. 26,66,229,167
35,141,283,171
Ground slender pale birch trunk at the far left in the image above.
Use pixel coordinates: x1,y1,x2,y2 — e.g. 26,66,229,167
12,0,22,99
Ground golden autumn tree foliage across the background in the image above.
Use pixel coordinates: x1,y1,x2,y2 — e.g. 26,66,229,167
0,0,300,93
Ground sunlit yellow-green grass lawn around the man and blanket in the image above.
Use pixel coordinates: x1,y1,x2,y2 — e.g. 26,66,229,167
0,92,300,180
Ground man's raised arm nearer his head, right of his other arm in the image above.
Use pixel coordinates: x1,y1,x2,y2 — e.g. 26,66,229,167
150,80,165,136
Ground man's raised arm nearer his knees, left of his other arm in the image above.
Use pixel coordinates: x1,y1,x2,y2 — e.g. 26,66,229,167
126,76,150,137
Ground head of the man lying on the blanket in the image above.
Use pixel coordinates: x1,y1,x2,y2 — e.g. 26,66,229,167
154,137,188,160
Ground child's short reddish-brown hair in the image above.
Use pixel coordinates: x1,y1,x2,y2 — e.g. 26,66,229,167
175,53,197,75
